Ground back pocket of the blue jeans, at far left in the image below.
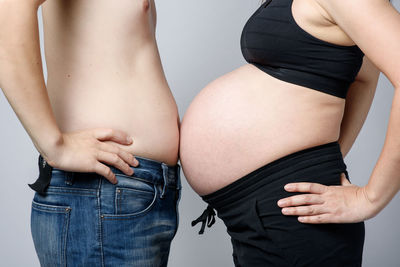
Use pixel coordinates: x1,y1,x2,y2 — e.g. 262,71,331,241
31,200,71,267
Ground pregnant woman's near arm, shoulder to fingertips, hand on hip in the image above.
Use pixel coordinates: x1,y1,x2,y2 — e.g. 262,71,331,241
278,0,400,223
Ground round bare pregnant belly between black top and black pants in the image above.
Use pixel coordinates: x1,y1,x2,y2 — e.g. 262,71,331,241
180,65,345,195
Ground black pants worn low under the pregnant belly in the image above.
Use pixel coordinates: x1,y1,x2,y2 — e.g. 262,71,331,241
198,142,365,267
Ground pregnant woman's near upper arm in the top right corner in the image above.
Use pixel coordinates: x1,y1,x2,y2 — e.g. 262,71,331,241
318,0,400,88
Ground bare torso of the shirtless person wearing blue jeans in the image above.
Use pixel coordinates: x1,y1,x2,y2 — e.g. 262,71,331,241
43,0,179,165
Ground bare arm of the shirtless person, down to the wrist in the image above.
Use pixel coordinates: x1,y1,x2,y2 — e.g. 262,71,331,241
0,0,61,158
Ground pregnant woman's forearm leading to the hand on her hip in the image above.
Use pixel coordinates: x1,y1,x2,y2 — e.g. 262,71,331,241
365,89,400,215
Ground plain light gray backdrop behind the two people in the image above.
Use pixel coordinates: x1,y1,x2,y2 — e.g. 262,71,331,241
0,0,400,267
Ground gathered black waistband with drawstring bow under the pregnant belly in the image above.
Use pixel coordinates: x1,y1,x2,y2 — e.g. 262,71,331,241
192,141,349,234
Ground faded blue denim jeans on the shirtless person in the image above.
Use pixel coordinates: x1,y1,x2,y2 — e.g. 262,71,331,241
31,157,181,267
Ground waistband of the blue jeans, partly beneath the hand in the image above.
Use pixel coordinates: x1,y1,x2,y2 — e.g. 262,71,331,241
28,155,181,194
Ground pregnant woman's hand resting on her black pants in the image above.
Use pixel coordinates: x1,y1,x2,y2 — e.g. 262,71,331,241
278,173,378,224
